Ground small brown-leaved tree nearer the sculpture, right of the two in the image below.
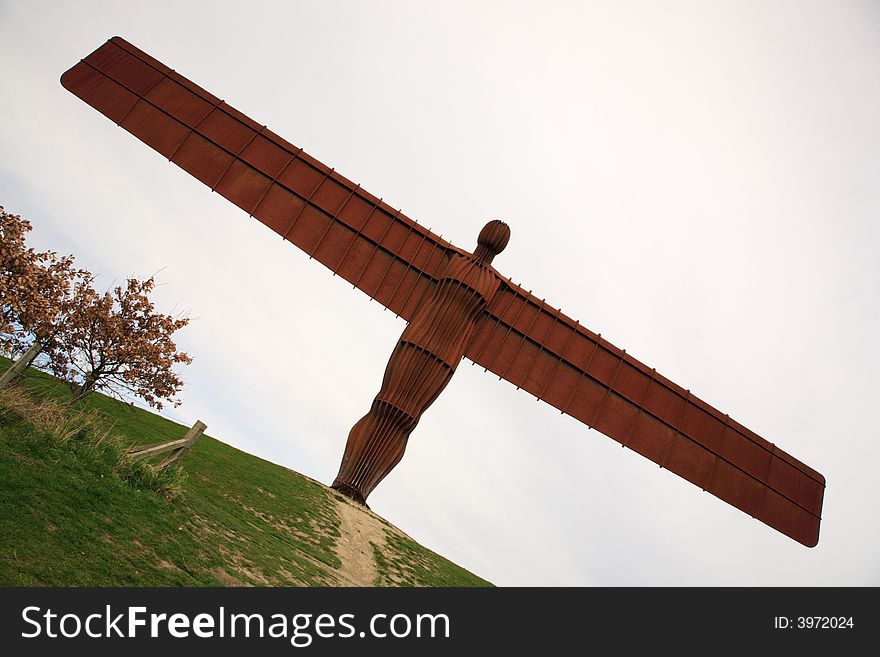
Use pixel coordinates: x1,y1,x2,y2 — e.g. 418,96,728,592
53,277,192,409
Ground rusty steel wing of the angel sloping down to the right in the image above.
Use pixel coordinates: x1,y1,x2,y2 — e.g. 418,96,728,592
465,281,825,547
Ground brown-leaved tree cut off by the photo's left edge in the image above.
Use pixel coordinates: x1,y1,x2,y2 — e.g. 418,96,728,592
0,206,92,366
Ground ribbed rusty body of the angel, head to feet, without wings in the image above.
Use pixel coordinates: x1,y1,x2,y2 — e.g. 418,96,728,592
333,221,510,504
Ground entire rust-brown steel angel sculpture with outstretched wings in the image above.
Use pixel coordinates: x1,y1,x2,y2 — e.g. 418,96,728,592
61,37,825,546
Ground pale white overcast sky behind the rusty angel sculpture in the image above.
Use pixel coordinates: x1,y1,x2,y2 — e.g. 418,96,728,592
0,0,880,586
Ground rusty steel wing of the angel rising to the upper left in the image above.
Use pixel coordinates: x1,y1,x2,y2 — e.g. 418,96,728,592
61,37,457,320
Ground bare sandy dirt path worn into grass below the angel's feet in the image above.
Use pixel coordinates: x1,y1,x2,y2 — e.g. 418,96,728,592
335,496,385,586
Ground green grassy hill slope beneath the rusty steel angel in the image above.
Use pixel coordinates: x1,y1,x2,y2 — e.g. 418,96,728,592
0,359,489,586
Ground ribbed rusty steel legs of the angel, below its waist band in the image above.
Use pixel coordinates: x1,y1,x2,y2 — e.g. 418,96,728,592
333,341,452,504
